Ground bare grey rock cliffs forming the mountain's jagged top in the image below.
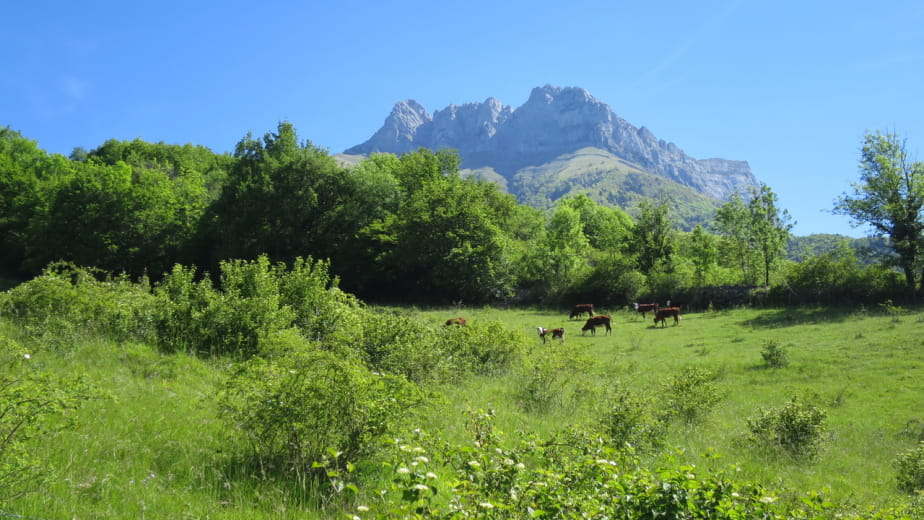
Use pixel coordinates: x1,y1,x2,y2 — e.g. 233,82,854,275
345,85,757,200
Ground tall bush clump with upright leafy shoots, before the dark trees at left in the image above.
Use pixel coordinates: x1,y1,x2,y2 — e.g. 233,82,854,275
155,256,360,358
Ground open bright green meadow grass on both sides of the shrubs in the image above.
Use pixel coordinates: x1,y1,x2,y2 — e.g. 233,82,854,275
0,307,924,519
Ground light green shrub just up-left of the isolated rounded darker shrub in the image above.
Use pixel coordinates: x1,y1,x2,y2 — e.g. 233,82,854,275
661,367,722,424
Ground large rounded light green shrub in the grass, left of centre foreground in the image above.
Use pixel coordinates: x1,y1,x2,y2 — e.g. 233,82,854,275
221,344,417,475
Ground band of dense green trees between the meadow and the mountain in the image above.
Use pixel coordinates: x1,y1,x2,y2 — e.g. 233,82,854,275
0,122,924,306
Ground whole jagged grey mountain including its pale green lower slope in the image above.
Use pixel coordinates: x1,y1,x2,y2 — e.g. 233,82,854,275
344,85,758,223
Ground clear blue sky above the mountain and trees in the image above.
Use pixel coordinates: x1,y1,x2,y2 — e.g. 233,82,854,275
0,0,924,236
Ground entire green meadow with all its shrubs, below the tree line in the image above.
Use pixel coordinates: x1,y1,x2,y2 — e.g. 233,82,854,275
0,259,924,518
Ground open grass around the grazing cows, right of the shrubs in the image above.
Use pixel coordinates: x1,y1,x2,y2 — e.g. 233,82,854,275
414,308,924,504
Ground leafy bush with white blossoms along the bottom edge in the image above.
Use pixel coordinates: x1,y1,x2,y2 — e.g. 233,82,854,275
370,411,918,520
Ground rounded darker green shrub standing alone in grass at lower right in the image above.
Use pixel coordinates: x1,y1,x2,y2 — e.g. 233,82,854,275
747,397,828,458
